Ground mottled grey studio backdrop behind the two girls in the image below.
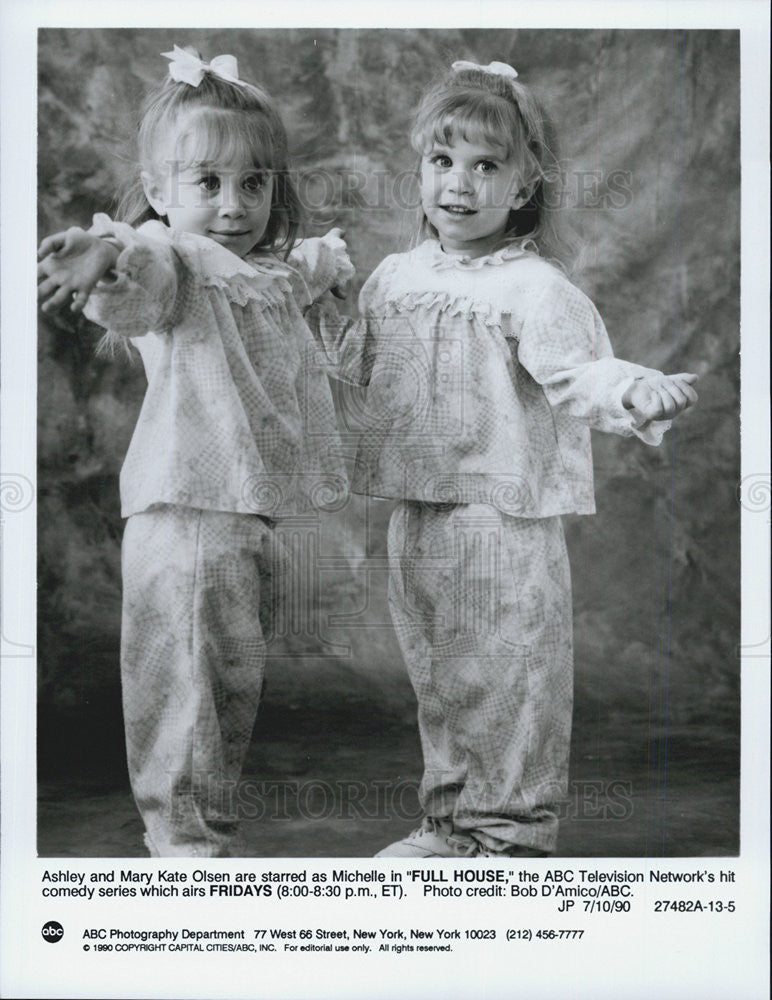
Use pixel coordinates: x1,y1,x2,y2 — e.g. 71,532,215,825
38,31,739,792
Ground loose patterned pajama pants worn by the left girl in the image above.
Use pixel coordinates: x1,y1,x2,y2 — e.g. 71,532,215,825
121,505,286,857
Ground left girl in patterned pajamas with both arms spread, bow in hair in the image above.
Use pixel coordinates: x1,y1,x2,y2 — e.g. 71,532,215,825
38,46,351,857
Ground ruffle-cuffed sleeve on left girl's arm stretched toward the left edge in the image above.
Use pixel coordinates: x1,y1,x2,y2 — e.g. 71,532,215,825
84,214,183,337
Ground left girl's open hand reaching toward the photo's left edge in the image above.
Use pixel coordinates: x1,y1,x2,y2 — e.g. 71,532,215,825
38,226,119,313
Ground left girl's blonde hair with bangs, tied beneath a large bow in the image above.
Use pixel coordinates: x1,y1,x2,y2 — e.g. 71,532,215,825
117,57,302,256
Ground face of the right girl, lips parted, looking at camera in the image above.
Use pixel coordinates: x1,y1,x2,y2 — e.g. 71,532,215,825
421,138,527,257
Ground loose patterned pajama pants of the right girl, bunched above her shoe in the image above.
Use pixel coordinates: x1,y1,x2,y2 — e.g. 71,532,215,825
389,501,573,852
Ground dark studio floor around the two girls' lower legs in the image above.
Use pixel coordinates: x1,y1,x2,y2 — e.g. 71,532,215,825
38,698,739,858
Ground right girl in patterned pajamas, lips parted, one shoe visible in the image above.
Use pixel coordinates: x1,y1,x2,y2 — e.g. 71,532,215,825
316,63,697,857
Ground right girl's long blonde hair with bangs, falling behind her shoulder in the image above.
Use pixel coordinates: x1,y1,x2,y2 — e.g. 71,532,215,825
411,69,578,268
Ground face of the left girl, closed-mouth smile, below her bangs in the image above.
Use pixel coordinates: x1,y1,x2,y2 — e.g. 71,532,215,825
142,152,273,257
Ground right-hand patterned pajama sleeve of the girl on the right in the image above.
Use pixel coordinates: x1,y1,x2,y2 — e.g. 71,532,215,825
517,279,670,445
